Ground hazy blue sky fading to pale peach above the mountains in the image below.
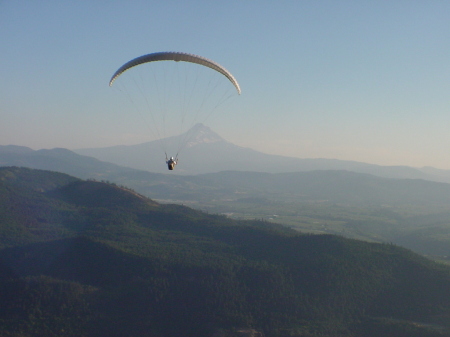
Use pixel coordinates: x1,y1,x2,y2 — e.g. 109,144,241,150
0,0,450,169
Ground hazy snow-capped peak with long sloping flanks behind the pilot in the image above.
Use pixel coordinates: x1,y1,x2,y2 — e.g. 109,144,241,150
74,124,450,182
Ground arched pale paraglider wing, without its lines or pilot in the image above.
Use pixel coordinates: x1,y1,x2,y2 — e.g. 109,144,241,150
109,52,241,95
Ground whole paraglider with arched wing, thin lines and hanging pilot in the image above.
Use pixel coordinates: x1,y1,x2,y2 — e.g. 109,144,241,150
109,52,241,171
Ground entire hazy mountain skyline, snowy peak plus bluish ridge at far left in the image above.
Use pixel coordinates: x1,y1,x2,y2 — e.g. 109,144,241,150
0,124,450,183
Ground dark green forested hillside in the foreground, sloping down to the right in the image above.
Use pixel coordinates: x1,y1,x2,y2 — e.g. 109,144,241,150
0,167,450,337
